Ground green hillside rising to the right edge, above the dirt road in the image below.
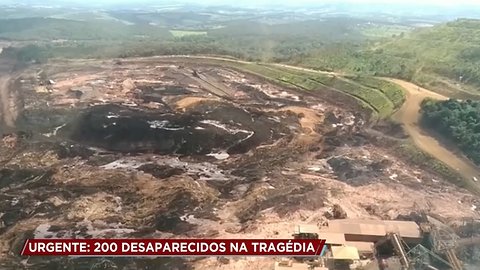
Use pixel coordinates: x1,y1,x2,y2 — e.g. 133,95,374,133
300,19,480,97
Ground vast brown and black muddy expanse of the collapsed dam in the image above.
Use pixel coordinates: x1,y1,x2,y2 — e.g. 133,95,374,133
0,57,480,269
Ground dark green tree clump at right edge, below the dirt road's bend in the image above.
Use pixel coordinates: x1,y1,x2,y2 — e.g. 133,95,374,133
422,99,480,164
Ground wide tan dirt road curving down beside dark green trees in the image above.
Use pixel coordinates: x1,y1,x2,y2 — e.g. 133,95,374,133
388,79,480,182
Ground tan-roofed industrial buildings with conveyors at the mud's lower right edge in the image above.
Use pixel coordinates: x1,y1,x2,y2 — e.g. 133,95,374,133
275,218,480,270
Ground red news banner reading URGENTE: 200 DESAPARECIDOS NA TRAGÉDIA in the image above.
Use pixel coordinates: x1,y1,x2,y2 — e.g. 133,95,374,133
21,239,325,257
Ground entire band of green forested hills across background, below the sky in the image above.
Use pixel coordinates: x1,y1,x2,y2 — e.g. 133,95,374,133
0,9,480,96
